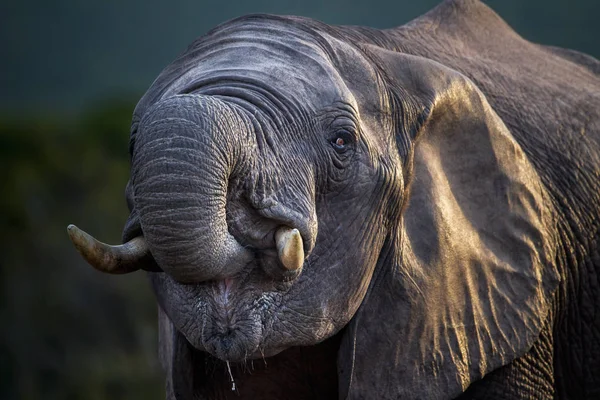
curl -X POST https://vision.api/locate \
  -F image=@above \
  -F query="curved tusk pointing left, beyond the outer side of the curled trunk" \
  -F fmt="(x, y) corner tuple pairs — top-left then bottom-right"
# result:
(67, 225), (160, 274)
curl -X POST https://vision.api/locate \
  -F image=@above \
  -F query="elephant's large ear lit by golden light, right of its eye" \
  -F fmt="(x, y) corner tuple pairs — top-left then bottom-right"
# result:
(338, 48), (559, 399)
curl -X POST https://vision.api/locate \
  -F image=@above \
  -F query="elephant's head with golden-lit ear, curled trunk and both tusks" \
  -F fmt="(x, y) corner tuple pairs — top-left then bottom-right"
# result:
(71, 16), (558, 399)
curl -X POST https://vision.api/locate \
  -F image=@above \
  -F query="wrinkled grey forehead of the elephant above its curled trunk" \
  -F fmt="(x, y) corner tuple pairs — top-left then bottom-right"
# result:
(140, 17), (354, 111)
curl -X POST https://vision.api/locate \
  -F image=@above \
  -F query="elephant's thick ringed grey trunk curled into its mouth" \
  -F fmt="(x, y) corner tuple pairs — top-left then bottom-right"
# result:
(132, 95), (252, 283)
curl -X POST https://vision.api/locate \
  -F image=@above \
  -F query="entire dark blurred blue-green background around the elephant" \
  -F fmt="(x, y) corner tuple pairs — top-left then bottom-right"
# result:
(0, 0), (600, 399)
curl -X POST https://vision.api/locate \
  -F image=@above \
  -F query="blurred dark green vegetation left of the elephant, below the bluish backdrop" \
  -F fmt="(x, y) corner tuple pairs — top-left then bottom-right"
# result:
(0, 99), (164, 400)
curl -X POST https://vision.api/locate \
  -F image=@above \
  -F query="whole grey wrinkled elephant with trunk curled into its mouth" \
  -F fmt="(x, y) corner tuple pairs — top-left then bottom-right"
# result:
(68, 0), (600, 400)
